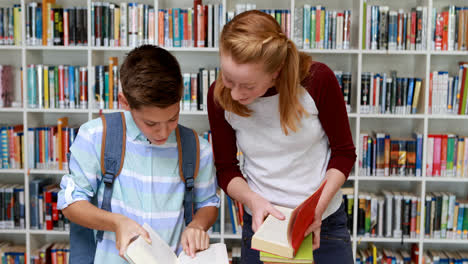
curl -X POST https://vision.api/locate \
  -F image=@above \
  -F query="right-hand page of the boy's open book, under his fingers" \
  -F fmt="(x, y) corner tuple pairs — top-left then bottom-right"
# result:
(179, 243), (229, 264)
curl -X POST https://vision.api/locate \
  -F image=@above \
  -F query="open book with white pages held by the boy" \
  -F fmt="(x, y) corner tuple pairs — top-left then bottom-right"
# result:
(125, 223), (229, 264)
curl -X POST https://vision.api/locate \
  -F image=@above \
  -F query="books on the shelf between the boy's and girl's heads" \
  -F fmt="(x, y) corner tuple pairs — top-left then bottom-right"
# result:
(180, 68), (219, 111)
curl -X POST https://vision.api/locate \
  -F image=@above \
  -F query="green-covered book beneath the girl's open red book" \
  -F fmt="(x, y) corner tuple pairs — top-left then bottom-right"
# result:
(260, 234), (314, 263)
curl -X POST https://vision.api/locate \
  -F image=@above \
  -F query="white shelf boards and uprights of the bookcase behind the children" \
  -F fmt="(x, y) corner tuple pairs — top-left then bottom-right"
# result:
(0, 0), (468, 263)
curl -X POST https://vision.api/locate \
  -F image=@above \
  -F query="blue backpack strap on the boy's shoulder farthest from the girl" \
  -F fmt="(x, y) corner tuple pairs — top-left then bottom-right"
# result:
(96, 112), (126, 241)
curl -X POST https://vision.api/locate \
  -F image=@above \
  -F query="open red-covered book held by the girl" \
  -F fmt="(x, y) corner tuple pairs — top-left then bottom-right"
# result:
(252, 180), (326, 259)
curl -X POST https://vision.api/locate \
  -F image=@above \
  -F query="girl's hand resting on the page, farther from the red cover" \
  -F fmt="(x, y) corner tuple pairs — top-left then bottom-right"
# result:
(247, 193), (285, 232)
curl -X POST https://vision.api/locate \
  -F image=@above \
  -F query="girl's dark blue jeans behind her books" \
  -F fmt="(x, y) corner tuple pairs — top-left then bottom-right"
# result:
(241, 203), (354, 264)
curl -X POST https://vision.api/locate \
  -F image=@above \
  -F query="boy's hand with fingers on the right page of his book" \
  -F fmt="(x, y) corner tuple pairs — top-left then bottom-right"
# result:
(181, 225), (210, 258)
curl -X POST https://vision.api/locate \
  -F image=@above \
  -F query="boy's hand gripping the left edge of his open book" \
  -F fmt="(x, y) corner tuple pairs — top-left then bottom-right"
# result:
(115, 214), (151, 259)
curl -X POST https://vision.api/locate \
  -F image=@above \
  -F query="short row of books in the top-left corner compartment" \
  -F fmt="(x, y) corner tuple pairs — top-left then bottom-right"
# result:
(0, 4), (22, 45)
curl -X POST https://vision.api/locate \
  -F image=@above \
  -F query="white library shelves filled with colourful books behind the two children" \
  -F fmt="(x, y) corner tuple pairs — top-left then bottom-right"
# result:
(0, 0), (468, 264)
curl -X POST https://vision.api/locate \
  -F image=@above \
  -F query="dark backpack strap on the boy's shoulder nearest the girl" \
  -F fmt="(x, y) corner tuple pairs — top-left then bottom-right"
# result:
(176, 125), (200, 226)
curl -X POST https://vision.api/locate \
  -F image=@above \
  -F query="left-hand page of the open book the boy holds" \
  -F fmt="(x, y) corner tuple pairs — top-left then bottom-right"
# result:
(125, 223), (179, 264)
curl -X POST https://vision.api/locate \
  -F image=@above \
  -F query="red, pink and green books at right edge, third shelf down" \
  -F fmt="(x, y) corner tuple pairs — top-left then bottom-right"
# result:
(426, 134), (468, 178)
